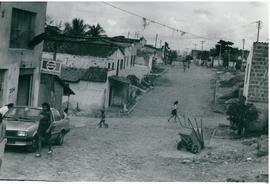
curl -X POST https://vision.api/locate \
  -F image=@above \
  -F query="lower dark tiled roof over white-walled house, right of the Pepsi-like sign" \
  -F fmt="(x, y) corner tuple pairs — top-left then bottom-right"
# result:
(61, 67), (108, 83)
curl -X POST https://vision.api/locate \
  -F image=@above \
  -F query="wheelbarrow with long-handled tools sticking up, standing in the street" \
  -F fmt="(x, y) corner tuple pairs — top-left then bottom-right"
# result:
(177, 119), (204, 153)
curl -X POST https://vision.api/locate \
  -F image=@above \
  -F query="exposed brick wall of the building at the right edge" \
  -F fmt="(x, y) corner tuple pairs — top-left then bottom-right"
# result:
(247, 42), (268, 103)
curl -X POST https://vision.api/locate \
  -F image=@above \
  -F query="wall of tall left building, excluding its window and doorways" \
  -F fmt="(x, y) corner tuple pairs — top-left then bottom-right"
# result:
(0, 2), (47, 106)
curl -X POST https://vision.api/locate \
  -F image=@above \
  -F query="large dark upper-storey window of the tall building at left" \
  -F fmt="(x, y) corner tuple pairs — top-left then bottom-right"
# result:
(10, 8), (36, 49)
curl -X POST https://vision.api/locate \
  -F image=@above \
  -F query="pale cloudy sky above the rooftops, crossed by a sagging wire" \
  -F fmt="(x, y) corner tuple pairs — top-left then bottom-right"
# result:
(47, 1), (269, 51)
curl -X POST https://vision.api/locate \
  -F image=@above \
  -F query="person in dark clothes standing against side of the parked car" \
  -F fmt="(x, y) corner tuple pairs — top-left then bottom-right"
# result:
(36, 102), (52, 157)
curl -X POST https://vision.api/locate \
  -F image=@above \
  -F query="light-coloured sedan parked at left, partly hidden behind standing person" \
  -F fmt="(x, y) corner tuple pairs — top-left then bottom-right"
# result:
(3, 106), (70, 152)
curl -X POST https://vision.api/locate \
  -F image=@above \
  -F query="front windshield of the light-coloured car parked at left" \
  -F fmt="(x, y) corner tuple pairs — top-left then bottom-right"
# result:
(5, 107), (41, 121)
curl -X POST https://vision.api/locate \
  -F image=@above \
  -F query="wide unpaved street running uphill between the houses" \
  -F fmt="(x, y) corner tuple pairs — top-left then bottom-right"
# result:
(0, 65), (268, 182)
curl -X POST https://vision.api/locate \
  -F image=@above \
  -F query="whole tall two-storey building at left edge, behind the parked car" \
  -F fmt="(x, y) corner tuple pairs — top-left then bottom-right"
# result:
(0, 2), (47, 106)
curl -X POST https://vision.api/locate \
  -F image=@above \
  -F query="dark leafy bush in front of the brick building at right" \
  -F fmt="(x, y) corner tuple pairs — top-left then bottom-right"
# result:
(226, 99), (259, 135)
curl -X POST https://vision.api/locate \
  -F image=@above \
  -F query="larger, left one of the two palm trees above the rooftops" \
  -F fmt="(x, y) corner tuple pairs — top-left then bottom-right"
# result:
(64, 18), (88, 36)
